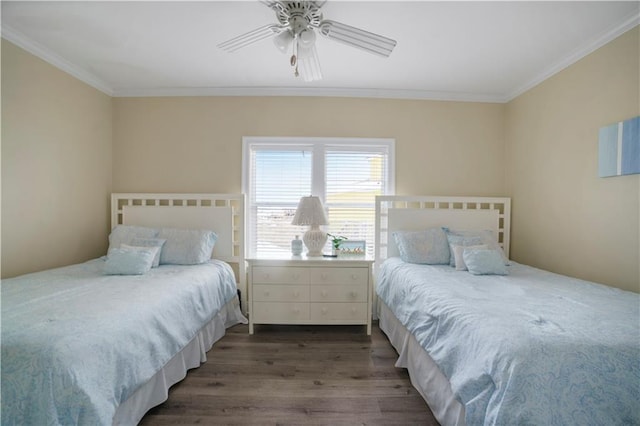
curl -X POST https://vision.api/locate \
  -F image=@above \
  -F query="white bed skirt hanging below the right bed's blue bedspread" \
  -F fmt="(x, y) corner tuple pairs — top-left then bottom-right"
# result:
(378, 299), (465, 426)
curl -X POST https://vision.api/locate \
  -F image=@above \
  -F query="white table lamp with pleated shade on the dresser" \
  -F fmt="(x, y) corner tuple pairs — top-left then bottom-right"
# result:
(291, 195), (329, 256)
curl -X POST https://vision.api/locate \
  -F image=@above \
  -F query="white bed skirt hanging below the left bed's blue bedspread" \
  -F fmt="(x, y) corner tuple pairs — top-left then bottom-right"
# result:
(113, 297), (248, 426)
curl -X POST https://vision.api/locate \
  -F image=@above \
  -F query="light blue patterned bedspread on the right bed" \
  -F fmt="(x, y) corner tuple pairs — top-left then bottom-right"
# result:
(377, 258), (640, 425)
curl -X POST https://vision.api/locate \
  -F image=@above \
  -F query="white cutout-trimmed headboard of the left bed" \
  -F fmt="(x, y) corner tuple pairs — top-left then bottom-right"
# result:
(111, 193), (247, 306)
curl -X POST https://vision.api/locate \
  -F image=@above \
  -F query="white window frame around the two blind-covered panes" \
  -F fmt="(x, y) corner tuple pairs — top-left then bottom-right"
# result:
(242, 136), (396, 257)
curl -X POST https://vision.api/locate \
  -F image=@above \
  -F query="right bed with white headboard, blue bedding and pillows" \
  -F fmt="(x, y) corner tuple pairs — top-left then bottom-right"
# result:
(375, 196), (640, 426)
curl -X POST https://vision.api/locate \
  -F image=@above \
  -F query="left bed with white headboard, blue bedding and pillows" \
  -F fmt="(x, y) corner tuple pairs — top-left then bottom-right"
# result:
(0, 193), (247, 426)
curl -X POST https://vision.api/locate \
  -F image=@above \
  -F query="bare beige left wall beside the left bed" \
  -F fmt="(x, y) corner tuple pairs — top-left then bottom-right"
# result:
(2, 39), (112, 278)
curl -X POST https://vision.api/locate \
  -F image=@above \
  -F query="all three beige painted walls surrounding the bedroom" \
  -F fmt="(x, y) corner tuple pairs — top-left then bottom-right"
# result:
(2, 28), (640, 291)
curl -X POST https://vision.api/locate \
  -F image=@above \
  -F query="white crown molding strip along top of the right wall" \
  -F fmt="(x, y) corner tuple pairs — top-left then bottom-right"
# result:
(503, 12), (640, 102)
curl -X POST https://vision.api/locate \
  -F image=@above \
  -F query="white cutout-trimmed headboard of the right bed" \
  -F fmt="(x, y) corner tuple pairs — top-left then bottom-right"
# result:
(375, 195), (511, 267)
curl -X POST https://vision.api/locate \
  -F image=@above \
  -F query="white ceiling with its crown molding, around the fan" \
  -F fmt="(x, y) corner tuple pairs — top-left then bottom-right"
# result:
(2, 0), (640, 102)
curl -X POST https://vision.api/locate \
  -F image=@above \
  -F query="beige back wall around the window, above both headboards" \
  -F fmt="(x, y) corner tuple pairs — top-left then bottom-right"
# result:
(113, 97), (504, 195)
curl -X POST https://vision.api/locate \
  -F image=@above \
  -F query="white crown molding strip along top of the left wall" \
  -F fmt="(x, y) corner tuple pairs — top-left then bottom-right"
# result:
(2, 24), (113, 96)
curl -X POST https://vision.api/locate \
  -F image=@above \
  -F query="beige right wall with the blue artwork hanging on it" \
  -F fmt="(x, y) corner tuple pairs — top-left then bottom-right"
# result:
(505, 27), (640, 292)
